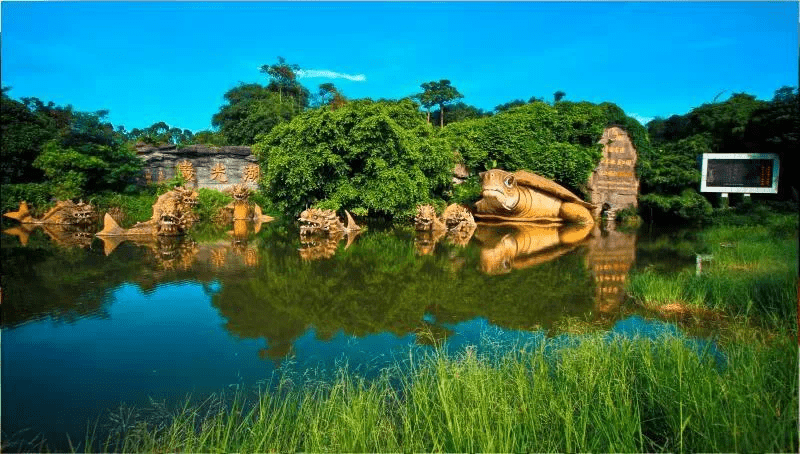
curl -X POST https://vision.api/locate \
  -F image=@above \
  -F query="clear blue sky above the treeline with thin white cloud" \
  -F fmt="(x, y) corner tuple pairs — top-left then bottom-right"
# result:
(1, 2), (799, 131)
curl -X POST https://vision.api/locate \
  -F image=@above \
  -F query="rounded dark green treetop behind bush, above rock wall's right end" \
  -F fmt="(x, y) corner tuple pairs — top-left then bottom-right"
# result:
(211, 83), (295, 145)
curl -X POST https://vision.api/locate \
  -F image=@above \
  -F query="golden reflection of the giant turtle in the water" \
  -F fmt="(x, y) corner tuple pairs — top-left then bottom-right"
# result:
(475, 222), (592, 274)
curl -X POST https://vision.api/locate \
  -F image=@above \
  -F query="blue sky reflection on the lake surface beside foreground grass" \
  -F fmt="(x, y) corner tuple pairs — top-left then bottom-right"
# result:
(2, 281), (723, 446)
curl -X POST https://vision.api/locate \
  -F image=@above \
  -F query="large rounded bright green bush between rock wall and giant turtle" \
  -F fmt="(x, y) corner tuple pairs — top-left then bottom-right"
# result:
(253, 100), (453, 216)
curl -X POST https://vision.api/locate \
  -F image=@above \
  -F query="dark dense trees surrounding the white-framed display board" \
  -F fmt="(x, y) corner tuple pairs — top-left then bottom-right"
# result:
(640, 87), (800, 219)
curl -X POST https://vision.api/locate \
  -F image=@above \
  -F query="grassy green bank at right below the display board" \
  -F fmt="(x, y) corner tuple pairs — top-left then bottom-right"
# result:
(627, 213), (798, 330)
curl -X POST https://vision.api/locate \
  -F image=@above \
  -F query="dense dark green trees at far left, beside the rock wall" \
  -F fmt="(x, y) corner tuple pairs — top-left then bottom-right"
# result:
(0, 91), (142, 204)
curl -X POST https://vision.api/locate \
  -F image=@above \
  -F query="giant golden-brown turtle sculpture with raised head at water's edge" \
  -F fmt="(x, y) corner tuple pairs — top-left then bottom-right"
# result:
(475, 169), (594, 224)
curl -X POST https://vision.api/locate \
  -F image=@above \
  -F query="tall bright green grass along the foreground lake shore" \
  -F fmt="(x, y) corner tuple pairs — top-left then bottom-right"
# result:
(83, 335), (798, 452)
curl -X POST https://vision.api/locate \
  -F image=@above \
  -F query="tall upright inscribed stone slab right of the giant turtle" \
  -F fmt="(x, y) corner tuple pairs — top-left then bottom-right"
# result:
(588, 126), (639, 220)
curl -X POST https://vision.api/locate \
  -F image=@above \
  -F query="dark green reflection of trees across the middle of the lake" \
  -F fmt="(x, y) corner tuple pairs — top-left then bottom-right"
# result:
(213, 232), (593, 357)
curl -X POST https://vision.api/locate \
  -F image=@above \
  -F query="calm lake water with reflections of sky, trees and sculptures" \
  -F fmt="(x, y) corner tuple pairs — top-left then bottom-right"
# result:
(1, 222), (703, 450)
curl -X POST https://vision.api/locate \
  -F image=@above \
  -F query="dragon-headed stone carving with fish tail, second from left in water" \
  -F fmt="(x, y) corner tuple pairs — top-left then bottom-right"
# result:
(97, 188), (197, 237)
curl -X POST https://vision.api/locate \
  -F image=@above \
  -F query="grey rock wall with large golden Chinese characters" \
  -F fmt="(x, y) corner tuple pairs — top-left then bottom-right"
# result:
(136, 144), (261, 191)
